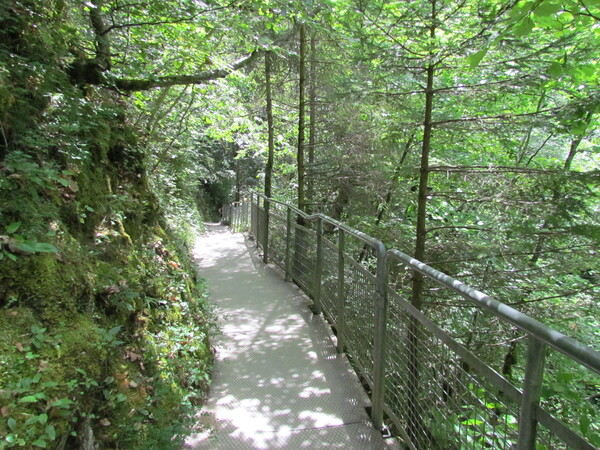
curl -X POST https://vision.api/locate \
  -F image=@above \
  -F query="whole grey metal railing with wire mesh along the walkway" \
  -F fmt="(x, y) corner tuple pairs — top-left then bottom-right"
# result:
(224, 194), (600, 449)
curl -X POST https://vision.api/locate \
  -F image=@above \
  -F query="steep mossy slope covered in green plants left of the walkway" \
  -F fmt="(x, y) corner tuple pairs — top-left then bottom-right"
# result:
(0, 1), (212, 448)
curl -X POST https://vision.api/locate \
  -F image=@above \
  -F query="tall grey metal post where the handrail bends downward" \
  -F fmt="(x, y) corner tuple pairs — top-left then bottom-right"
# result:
(371, 248), (387, 431)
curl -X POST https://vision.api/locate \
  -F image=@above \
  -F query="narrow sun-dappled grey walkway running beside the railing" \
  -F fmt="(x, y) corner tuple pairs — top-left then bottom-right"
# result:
(186, 224), (386, 450)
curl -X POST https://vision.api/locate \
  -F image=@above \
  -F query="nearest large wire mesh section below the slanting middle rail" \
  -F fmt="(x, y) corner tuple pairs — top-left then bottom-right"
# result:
(385, 292), (518, 449)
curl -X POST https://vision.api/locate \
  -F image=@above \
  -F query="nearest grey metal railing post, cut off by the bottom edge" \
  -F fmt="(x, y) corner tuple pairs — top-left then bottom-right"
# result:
(517, 336), (546, 450)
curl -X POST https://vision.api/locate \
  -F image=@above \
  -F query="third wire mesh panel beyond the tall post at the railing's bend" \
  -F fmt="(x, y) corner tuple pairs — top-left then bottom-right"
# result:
(292, 223), (317, 297)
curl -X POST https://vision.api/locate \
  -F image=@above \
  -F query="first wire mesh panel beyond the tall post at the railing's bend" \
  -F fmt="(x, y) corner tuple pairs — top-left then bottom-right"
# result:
(344, 256), (376, 384)
